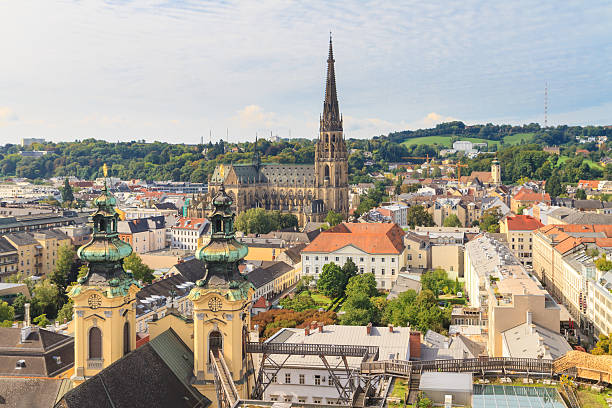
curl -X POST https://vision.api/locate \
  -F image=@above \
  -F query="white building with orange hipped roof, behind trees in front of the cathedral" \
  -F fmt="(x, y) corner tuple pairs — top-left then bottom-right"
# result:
(302, 223), (406, 290)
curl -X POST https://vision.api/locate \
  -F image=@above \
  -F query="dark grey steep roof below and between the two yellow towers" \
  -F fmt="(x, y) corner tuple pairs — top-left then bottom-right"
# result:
(57, 329), (211, 408)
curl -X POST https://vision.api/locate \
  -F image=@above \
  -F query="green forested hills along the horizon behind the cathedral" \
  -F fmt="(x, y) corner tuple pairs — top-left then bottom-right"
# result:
(0, 122), (612, 182)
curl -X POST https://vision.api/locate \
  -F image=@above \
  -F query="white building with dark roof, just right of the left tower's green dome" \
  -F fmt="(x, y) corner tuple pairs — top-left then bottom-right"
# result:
(117, 216), (167, 254)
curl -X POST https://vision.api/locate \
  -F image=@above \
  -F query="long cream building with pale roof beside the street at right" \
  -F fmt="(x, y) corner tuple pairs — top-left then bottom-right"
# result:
(465, 233), (571, 358)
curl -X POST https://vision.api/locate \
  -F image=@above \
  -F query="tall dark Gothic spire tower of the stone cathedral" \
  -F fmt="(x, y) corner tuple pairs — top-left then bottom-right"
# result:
(315, 36), (348, 215)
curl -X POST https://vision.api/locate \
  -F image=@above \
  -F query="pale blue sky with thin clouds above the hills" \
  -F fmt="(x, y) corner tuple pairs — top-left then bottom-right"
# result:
(0, 0), (612, 144)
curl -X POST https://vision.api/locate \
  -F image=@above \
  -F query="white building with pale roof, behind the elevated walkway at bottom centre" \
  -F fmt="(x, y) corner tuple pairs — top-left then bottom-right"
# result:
(263, 325), (410, 404)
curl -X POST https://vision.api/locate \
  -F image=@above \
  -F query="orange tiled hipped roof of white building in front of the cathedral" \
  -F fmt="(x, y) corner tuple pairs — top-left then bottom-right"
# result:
(302, 223), (404, 254)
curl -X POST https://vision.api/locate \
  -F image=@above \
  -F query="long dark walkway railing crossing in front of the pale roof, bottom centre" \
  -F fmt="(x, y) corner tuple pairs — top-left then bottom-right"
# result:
(246, 342), (378, 358)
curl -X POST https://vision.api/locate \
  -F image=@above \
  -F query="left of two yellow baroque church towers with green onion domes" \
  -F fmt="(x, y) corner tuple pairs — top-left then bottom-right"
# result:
(68, 165), (140, 385)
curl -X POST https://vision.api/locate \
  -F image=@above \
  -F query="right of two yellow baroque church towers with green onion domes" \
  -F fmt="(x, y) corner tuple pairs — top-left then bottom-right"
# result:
(189, 184), (254, 401)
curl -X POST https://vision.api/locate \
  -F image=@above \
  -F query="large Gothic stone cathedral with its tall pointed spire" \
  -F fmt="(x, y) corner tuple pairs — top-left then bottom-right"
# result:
(188, 38), (349, 225)
